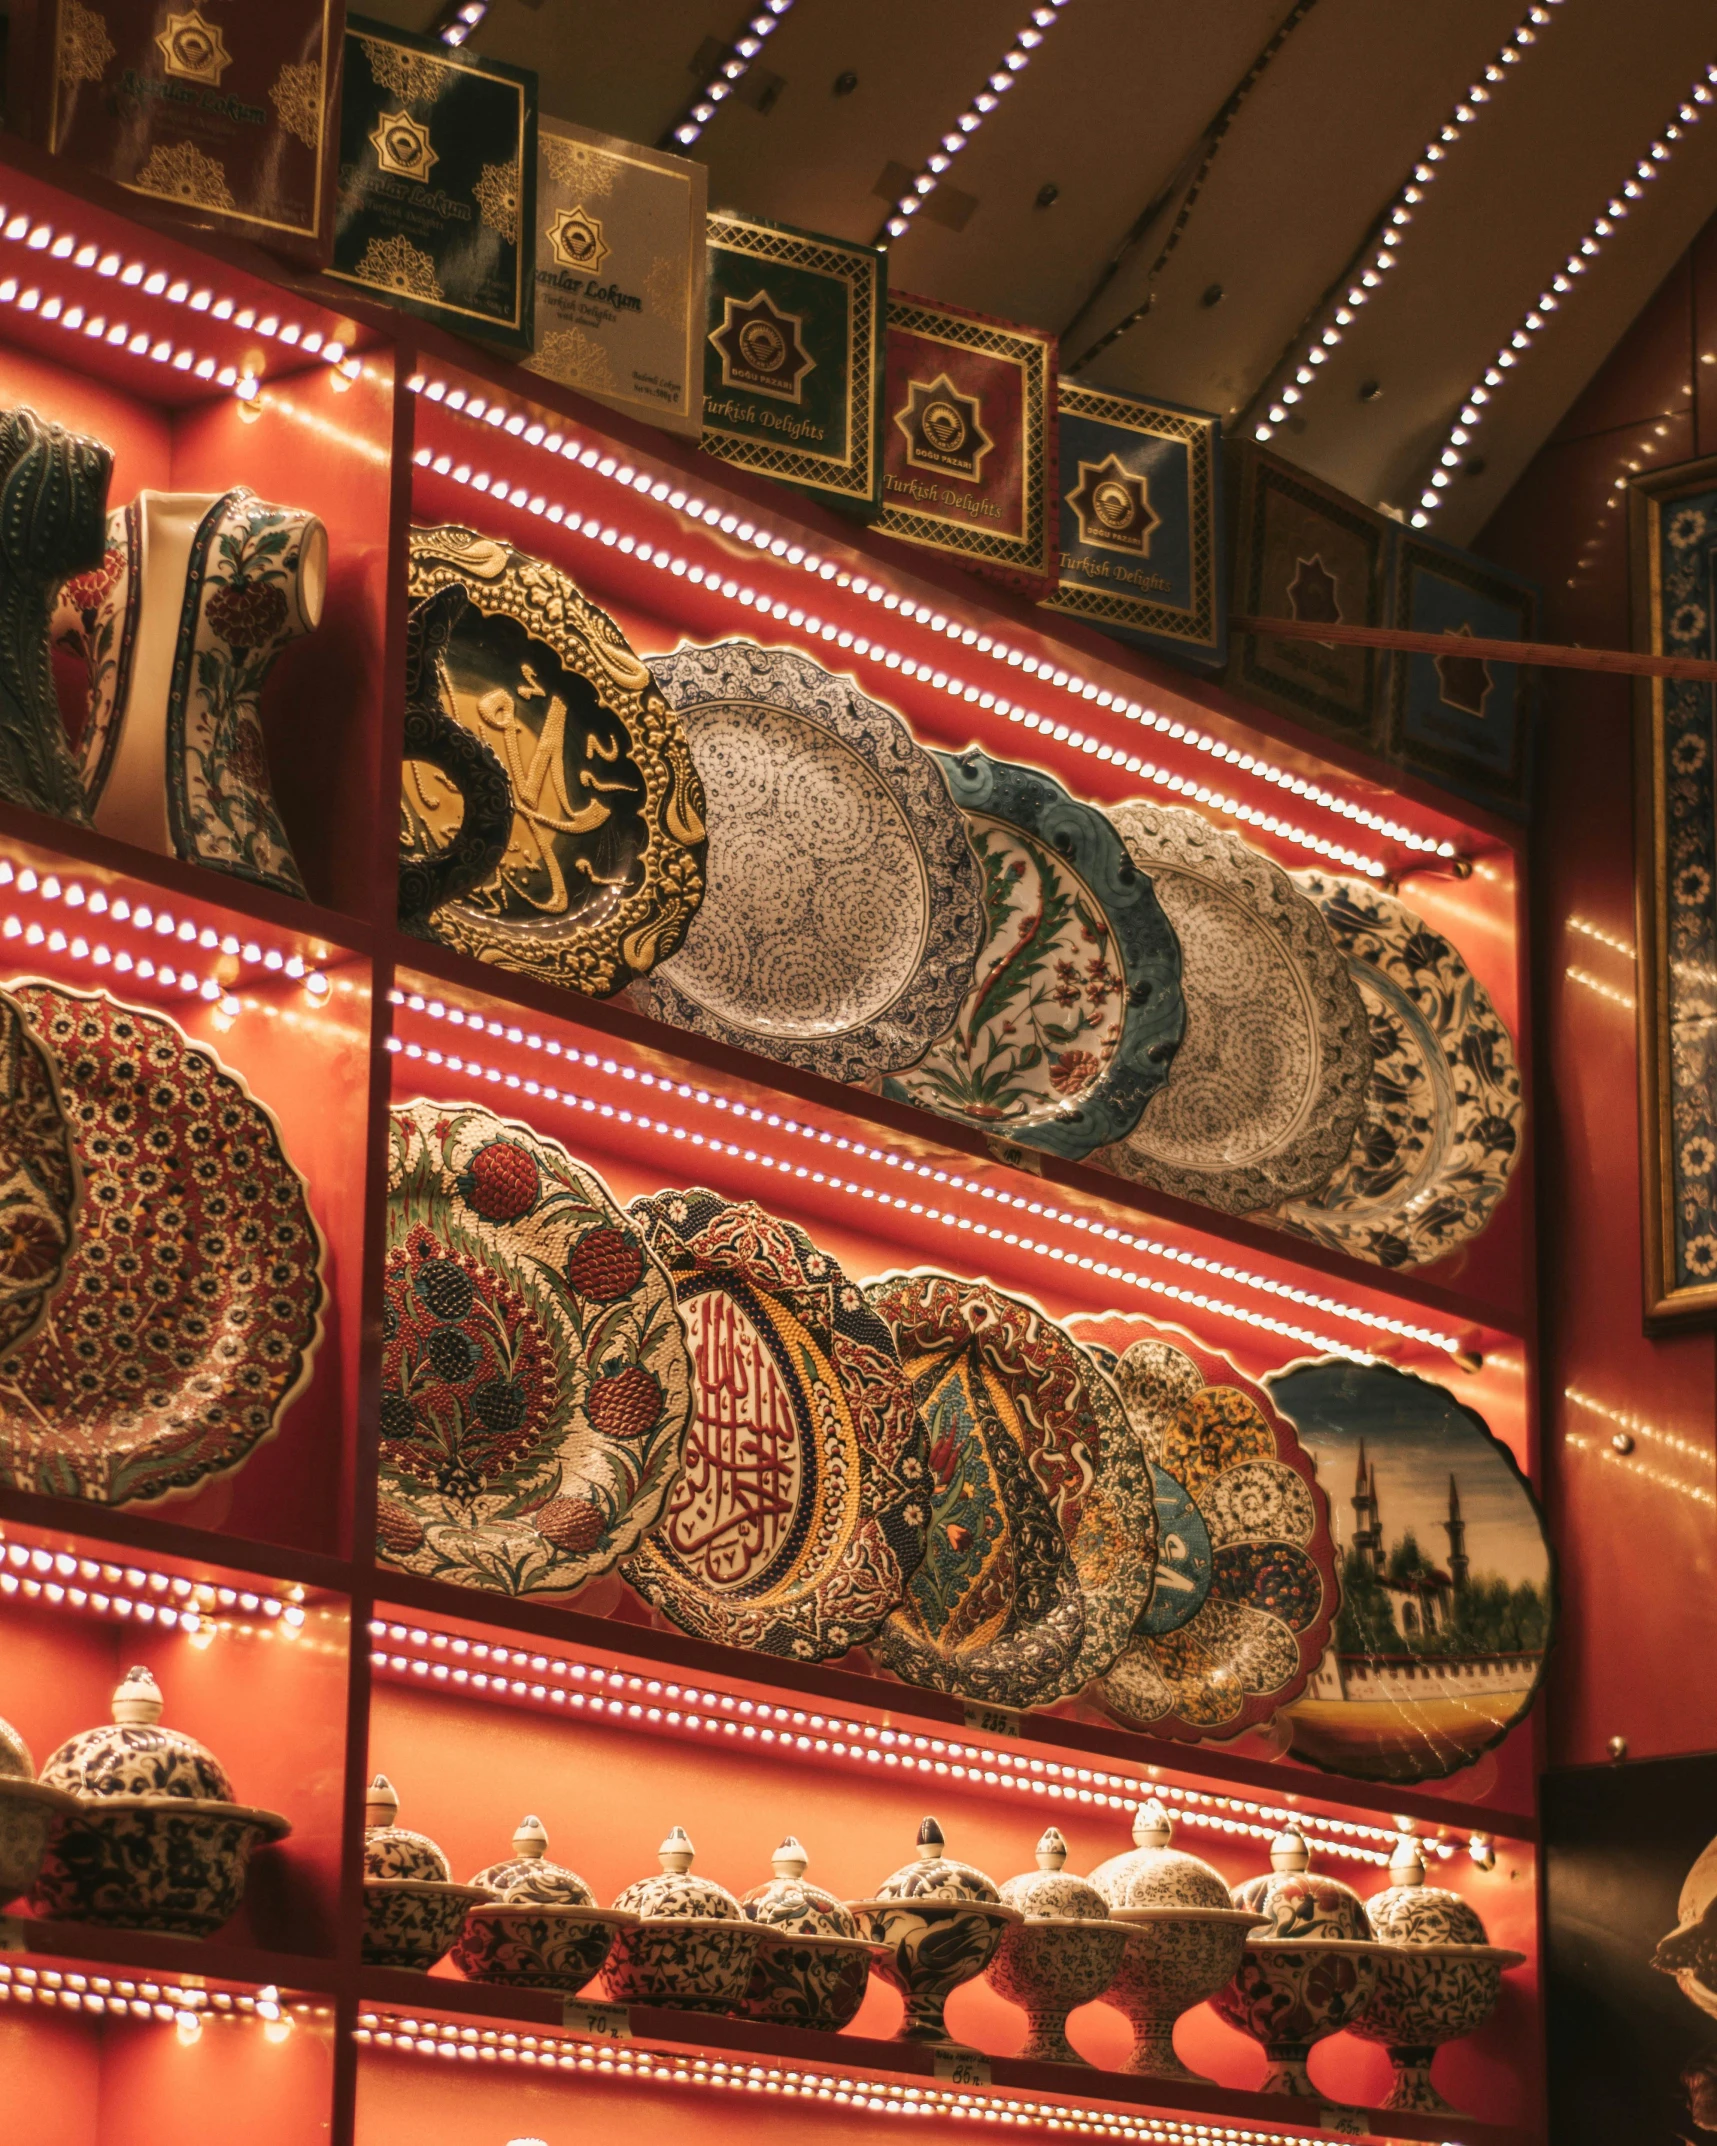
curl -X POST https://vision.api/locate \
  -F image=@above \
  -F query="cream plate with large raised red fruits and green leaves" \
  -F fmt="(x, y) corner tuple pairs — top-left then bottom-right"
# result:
(376, 1101), (691, 1594)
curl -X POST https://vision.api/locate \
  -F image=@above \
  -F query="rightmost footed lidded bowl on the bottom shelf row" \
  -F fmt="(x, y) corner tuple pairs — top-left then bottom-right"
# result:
(1354, 1833), (1526, 2116)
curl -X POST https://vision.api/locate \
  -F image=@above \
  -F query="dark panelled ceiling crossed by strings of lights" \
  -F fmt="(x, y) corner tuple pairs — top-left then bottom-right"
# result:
(365, 0), (1717, 543)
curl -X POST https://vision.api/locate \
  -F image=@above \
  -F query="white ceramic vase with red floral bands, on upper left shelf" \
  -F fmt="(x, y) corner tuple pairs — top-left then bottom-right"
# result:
(54, 485), (328, 895)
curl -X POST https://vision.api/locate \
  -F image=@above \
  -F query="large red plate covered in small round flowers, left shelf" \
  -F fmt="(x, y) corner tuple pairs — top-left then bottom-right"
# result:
(0, 983), (322, 1504)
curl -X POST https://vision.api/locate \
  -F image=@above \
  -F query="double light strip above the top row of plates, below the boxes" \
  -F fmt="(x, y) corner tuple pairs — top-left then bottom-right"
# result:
(406, 373), (1459, 878)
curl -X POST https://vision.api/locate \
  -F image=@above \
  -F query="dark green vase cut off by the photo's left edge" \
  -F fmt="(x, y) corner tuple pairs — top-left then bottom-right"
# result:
(0, 410), (114, 826)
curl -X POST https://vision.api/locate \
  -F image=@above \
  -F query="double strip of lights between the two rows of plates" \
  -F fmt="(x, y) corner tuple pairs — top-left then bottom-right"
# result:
(386, 987), (1462, 1356)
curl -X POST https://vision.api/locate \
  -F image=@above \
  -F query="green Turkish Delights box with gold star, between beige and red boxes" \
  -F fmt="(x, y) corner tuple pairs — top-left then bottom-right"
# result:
(704, 215), (886, 515)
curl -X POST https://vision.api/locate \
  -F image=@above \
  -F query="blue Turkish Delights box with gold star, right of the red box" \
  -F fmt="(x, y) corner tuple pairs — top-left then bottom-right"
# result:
(1045, 380), (1228, 665)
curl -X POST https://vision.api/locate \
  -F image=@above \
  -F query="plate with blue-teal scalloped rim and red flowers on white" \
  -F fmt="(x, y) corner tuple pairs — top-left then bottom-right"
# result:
(886, 749), (1185, 1161)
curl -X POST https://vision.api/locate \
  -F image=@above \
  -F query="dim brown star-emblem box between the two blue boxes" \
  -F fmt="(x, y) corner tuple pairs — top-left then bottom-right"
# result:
(1223, 444), (1395, 753)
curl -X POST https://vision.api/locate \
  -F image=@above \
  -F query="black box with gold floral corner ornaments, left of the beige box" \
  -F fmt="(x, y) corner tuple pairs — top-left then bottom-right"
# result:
(331, 15), (537, 352)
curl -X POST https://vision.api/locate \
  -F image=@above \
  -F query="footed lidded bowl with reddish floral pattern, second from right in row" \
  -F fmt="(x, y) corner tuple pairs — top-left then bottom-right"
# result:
(1210, 1831), (1380, 2097)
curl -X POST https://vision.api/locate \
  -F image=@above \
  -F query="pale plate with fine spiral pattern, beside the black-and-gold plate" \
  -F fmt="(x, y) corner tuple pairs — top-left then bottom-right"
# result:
(633, 642), (983, 1079)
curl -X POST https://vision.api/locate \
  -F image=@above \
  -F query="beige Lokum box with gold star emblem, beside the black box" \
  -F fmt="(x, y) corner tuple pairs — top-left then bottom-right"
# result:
(524, 118), (708, 440)
